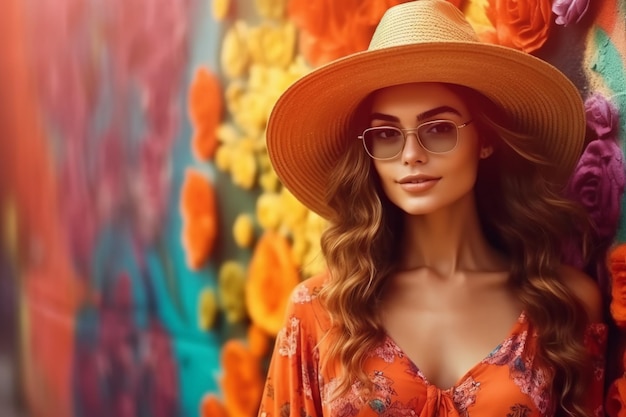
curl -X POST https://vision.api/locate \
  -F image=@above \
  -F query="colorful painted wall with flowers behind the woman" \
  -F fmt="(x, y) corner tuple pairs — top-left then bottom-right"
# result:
(0, 0), (626, 417)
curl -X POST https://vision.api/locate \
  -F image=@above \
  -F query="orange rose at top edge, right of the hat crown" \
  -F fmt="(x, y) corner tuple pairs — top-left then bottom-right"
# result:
(483, 0), (552, 52)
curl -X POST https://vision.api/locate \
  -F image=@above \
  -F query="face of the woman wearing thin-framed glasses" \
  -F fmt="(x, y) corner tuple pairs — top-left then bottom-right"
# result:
(369, 83), (491, 215)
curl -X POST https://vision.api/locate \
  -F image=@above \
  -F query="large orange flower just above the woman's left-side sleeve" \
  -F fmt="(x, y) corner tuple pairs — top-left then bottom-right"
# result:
(246, 232), (300, 336)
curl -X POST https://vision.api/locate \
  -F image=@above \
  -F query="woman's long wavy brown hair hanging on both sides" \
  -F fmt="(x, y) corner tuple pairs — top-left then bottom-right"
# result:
(321, 85), (589, 417)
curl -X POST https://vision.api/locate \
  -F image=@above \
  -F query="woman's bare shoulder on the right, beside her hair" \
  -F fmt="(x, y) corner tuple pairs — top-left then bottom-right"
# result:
(559, 265), (603, 323)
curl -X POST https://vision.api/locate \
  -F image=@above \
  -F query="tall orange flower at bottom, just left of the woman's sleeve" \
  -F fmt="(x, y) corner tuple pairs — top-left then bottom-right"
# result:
(221, 339), (263, 417)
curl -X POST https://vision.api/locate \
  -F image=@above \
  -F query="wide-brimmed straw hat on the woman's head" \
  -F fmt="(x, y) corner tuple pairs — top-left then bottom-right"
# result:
(266, 0), (585, 217)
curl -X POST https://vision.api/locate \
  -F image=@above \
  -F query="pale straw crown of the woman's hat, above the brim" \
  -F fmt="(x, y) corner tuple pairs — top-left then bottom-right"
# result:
(368, 0), (479, 51)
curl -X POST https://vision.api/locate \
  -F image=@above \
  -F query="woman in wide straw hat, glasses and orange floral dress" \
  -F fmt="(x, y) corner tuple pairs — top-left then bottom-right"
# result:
(259, 0), (606, 417)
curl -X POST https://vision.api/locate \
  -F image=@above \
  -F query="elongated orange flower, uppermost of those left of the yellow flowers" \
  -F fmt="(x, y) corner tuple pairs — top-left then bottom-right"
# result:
(189, 67), (224, 160)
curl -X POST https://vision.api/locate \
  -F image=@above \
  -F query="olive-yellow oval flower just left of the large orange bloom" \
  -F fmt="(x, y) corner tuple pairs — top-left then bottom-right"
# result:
(218, 261), (246, 323)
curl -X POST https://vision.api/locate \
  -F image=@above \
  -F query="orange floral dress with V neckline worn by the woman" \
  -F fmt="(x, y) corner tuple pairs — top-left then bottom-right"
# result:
(258, 276), (607, 417)
